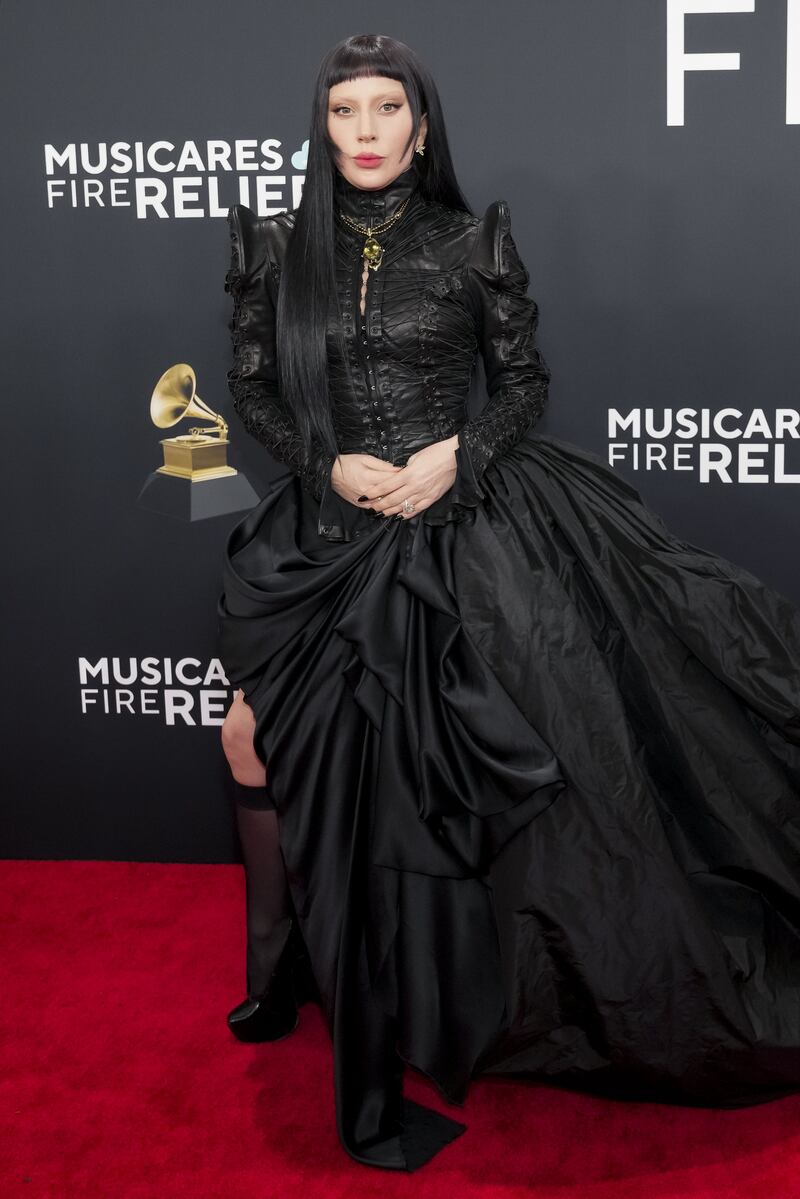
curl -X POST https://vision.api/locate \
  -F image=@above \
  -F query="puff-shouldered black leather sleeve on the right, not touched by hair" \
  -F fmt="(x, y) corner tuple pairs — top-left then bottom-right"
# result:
(458, 200), (551, 480)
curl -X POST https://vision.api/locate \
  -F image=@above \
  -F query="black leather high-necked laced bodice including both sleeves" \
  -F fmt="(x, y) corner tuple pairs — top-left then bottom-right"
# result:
(225, 162), (549, 540)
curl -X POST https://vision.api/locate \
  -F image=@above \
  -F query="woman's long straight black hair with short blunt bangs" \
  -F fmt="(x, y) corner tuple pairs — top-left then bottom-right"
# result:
(276, 34), (473, 453)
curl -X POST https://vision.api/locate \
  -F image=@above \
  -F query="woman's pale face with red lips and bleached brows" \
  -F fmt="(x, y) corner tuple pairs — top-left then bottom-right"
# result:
(327, 76), (428, 189)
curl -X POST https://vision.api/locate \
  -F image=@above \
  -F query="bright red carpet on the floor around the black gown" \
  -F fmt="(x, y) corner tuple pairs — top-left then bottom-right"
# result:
(0, 861), (800, 1199)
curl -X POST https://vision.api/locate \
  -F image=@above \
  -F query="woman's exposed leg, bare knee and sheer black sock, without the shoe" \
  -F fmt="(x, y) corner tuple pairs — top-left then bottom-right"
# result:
(222, 691), (293, 999)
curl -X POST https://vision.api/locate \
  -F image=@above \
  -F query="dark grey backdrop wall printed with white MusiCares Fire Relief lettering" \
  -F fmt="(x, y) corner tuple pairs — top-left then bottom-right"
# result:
(0, 0), (800, 861)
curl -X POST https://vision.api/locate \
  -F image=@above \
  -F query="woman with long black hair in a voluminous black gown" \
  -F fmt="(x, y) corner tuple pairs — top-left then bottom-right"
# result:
(219, 35), (800, 1170)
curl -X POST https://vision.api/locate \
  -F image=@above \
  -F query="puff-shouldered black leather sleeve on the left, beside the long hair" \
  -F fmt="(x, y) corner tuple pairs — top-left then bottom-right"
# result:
(225, 204), (336, 500)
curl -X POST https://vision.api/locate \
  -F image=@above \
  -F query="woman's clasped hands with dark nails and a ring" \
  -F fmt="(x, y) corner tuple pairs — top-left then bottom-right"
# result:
(331, 434), (458, 519)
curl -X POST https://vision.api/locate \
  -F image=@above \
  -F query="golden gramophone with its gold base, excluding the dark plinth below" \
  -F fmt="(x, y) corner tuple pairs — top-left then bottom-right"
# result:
(150, 362), (237, 483)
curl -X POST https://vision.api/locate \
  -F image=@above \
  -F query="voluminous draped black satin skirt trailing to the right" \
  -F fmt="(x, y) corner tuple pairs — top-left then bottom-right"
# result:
(219, 432), (800, 1170)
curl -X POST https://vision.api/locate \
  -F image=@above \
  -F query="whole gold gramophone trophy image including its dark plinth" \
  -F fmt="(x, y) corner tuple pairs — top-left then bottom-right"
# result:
(138, 362), (258, 520)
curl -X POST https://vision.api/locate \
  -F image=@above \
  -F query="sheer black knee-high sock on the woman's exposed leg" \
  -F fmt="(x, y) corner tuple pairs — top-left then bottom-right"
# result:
(235, 783), (293, 999)
